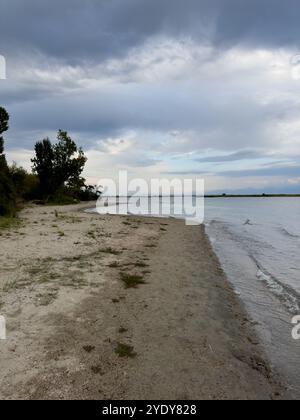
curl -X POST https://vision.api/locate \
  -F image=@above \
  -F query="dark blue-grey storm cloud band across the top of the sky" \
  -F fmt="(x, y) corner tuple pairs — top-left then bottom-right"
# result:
(0, 0), (300, 62)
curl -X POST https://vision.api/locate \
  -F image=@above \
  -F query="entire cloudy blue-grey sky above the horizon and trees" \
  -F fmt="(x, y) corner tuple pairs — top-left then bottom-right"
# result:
(0, 0), (300, 193)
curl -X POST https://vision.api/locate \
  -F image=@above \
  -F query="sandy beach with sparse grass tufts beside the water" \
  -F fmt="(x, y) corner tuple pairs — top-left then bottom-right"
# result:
(0, 206), (283, 399)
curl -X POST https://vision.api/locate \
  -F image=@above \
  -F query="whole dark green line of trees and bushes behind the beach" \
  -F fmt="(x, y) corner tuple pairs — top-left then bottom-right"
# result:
(0, 107), (98, 216)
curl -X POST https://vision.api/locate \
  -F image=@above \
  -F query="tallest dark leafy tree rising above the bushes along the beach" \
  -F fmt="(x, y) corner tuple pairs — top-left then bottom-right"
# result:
(32, 130), (86, 199)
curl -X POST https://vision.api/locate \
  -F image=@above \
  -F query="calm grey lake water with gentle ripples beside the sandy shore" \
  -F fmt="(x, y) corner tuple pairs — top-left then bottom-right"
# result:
(89, 198), (300, 397)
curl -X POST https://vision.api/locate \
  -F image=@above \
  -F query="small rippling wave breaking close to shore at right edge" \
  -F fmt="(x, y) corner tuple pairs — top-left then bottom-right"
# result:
(251, 256), (300, 315)
